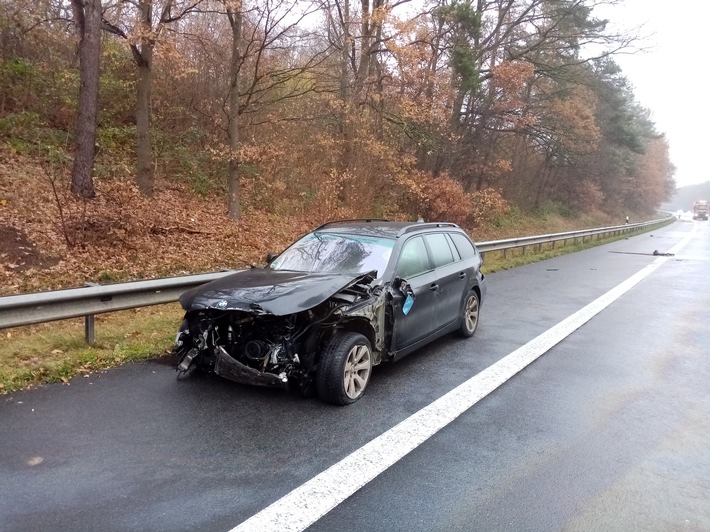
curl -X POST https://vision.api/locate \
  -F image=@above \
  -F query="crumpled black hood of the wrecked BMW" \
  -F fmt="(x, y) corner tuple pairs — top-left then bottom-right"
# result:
(180, 268), (374, 316)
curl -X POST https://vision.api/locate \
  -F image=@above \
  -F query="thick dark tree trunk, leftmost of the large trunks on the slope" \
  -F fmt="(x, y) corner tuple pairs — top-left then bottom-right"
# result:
(71, 0), (101, 198)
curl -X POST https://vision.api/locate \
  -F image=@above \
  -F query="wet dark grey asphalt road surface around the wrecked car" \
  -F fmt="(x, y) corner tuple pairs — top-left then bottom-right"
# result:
(0, 223), (710, 531)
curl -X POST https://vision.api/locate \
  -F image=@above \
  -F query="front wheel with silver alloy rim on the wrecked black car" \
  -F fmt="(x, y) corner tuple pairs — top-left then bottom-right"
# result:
(316, 332), (372, 405)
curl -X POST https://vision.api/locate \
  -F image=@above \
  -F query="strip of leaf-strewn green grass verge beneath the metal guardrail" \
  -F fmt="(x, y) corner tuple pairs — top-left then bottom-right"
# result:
(0, 213), (672, 393)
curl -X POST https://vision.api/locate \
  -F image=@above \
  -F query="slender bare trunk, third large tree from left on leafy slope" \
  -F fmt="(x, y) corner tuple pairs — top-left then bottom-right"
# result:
(227, 8), (242, 220)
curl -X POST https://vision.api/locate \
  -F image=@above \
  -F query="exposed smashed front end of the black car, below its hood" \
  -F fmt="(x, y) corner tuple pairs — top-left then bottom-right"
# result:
(175, 274), (384, 390)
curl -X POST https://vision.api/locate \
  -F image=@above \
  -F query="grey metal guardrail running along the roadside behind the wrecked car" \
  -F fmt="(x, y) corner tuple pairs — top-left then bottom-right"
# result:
(0, 218), (672, 345)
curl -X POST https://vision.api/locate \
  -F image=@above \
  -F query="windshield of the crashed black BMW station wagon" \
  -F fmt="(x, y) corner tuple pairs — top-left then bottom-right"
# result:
(269, 233), (394, 277)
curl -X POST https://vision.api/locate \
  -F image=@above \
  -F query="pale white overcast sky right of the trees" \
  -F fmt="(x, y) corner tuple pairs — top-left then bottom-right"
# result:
(594, 0), (710, 187)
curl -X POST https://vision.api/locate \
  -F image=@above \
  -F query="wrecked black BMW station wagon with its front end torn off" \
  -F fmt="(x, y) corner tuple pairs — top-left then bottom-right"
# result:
(175, 220), (486, 405)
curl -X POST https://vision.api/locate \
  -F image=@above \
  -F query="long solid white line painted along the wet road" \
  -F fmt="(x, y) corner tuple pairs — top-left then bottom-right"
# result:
(230, 225), (696, 532)
